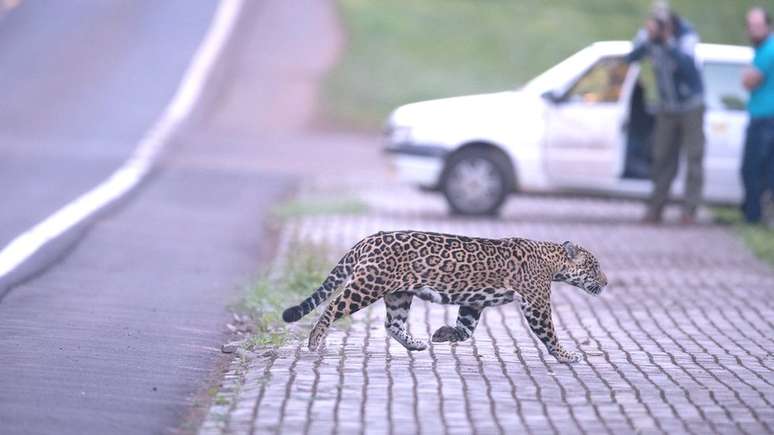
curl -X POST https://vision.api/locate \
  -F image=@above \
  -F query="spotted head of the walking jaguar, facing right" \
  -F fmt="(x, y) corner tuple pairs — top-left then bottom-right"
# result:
(554, 242), (607, 295)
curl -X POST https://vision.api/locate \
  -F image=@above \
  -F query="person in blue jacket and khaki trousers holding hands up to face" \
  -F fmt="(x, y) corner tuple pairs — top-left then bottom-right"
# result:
(626, 1), (704, 223)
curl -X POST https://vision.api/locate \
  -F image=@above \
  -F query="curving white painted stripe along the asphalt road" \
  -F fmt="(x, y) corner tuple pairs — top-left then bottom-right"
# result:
(0, 0), (243, 278)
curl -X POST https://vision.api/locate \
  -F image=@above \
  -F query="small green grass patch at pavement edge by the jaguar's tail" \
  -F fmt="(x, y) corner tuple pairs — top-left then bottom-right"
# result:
(244, 243), (333, 346)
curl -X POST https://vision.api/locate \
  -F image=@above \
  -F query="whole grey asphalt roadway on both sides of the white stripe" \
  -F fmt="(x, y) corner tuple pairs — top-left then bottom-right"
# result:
(0, 0), (350, 434)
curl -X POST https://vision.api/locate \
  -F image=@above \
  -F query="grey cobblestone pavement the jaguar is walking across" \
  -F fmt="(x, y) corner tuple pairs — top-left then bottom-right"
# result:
(201, 188), (774, 434)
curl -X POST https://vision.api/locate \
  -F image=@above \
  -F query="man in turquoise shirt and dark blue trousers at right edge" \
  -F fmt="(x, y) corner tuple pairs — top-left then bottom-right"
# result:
(742, 8), (774, 223)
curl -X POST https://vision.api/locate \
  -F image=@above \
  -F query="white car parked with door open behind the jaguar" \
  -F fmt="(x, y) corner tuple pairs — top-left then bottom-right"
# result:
(385, 41), (753, 215)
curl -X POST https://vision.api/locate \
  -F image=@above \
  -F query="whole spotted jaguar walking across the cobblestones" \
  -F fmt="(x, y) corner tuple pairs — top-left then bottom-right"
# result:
(282, 231), (607, 362)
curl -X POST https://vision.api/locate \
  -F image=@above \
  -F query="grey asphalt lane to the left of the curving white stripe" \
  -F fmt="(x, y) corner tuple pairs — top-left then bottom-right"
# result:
(0, 1), (215, 255)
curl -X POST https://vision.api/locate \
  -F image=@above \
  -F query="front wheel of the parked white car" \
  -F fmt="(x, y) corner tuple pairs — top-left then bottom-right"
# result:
(441, 148), (512, 216)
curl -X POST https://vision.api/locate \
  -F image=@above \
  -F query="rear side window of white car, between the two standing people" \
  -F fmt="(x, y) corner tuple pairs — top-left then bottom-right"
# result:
(704, 61), (747, 111)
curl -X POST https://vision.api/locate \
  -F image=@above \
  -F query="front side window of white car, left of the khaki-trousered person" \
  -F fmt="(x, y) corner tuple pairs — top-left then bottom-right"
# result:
(565, 58), (629, 103)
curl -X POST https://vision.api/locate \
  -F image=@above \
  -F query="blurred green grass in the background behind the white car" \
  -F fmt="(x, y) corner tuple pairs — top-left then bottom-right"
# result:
(323, 0), (774, 129)
